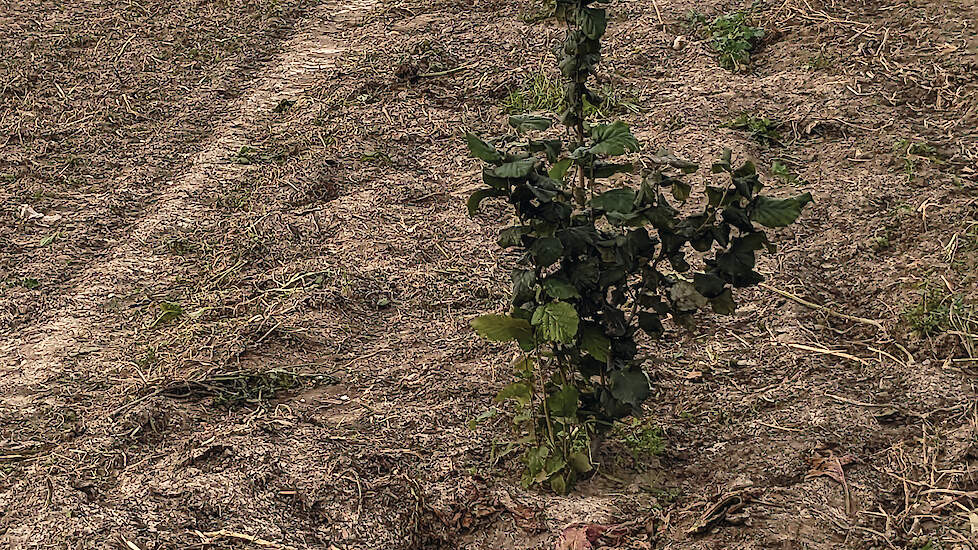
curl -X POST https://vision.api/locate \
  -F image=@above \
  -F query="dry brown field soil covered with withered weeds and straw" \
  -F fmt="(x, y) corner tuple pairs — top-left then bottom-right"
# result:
(0, 0), (978, 550)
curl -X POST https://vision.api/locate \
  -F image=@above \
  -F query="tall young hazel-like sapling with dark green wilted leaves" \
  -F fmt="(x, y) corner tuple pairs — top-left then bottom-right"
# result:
(466, 0), (812, 493)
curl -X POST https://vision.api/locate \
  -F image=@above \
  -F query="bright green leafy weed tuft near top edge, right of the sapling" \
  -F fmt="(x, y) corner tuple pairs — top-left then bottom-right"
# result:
(686, 10), (764, 72)
